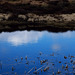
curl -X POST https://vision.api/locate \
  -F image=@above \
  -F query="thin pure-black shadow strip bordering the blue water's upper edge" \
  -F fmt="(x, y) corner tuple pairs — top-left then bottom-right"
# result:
(0, 26), (74, 33)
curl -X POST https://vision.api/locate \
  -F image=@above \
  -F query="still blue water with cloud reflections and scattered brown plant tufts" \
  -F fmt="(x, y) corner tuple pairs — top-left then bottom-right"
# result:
(0, 31), (75, 75)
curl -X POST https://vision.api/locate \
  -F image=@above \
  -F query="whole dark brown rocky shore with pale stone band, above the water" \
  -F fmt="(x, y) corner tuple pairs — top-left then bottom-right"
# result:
(0, 1), (75, 32)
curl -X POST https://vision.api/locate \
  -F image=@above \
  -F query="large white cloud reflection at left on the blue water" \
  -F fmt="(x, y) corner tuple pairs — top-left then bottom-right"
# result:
(0, 31), (43, 46)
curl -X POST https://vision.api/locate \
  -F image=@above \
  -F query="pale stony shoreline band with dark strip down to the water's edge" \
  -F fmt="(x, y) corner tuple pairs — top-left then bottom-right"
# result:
(0, 13), (75, 32)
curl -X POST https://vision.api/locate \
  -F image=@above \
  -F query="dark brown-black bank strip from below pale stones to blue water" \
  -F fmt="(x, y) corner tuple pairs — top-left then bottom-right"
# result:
(0, 22), (75, 32)
